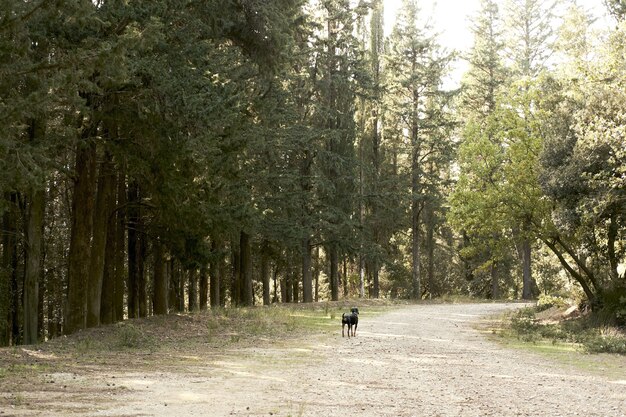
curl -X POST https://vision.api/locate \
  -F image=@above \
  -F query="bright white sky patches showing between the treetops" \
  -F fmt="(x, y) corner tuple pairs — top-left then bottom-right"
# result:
(383, 0), (606, 84)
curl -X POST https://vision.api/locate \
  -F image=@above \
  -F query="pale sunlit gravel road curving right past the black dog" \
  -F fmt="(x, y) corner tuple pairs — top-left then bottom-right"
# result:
(89, 304), (626, 417)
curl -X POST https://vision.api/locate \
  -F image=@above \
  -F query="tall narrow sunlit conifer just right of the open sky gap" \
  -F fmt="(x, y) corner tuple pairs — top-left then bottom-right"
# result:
(450, 0), (510, 298)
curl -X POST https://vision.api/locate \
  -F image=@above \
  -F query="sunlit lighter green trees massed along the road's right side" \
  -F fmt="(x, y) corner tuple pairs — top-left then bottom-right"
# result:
(450, 0), (626, 310)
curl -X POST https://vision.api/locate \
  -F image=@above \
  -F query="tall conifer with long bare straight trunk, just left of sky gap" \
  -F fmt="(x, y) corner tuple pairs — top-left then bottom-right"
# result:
(387, 0), (451, 299)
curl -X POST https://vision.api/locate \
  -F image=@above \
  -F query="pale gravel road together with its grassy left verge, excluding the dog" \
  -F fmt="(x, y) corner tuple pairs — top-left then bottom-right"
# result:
(0, 303), (626, 417)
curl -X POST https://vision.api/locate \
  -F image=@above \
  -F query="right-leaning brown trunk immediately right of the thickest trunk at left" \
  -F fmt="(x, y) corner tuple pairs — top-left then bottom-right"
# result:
(87, 152), (115, 327)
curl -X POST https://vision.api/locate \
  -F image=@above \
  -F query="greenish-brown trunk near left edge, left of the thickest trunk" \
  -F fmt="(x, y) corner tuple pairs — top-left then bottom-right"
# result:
(23, 189), (45, 345)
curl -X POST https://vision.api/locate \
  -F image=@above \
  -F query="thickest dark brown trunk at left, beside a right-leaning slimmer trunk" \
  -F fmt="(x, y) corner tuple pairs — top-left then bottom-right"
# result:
(63, 141), (96, 334)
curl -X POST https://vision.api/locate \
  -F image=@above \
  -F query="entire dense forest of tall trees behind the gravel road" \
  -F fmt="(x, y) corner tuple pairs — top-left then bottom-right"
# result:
(0, 0), (626, 346)
